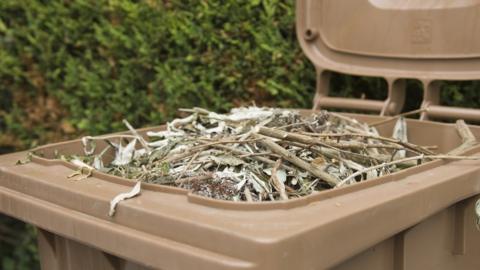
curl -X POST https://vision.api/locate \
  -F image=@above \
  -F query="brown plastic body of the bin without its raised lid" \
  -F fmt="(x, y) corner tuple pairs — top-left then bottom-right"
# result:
(0, 115), (480, 270)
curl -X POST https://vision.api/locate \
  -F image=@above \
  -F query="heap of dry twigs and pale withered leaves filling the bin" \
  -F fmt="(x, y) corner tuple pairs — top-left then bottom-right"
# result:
(64, 107), (476, 202)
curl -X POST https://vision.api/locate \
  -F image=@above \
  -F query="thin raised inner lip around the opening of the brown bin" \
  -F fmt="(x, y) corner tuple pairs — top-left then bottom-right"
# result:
(27, 110), (480, 211)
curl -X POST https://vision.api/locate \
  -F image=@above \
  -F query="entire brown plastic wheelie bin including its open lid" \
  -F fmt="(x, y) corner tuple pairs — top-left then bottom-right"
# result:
(0, 0), (480, 270)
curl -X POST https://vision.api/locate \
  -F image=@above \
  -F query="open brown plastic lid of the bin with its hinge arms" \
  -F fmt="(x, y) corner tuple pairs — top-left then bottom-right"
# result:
(296, 0), (480, 121)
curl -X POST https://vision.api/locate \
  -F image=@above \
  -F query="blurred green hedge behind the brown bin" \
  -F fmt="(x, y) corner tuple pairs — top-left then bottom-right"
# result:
(0, 0), (480, 270)
